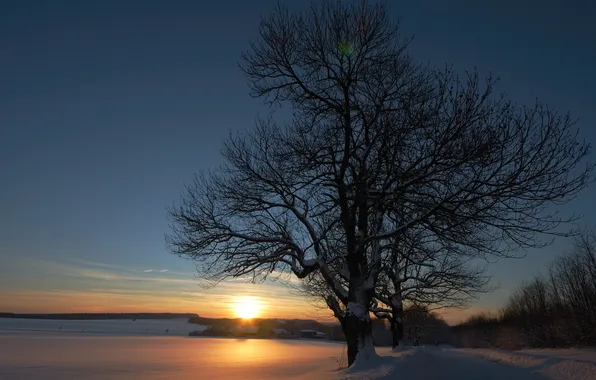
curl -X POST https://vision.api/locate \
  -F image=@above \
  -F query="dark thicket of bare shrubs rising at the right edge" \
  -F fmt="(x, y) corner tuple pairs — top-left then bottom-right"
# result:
(453, 230), (596, 349)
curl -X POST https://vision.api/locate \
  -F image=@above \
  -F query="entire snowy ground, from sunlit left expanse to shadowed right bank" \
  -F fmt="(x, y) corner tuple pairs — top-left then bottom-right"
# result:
(0, 319), (596, 380)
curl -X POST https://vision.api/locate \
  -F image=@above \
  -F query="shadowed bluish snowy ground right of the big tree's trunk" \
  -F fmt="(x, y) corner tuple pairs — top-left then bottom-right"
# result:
(338, 347), (596, 380)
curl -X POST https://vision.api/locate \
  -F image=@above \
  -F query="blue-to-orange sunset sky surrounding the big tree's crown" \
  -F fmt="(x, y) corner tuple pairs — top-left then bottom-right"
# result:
(0, 0), (596, 322)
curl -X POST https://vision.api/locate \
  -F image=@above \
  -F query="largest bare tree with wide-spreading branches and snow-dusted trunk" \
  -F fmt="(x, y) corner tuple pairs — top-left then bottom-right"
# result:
(167, 1), (591, 365)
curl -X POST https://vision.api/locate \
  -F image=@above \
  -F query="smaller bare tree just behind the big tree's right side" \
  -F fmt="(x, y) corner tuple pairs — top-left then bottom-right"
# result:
(371, 226), (491, 348)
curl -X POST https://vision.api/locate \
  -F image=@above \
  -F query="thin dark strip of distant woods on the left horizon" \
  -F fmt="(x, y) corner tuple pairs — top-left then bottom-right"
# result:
(0, 313), (199, 320)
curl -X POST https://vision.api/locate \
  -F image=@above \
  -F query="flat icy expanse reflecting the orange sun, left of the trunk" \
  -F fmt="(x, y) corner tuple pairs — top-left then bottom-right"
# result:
(0, 319), (344, 380)
